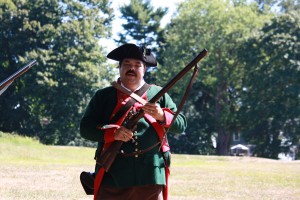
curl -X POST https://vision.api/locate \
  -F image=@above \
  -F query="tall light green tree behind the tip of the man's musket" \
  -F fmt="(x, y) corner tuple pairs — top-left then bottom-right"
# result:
(157, 0), (270, 155)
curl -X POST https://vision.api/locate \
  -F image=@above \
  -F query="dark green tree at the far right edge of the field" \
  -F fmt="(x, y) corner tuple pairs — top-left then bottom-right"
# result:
(240, 12), (300, 158)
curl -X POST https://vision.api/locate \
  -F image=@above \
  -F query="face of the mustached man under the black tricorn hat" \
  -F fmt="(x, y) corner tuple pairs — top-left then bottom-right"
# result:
(119, 58), (146, 90)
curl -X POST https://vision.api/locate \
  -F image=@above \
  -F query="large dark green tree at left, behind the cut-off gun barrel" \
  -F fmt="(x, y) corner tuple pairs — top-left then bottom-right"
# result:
(0, 0), (112, 144)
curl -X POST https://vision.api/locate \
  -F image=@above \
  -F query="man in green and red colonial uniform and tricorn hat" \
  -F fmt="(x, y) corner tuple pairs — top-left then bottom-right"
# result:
(80, 44), (186, 200)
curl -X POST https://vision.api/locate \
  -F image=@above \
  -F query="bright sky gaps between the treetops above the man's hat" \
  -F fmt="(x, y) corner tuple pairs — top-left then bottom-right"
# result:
(100, 0), (183, 52)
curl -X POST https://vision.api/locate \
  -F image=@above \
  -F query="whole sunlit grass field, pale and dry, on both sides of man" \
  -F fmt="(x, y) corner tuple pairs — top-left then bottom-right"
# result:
(0, 132), (300, 200)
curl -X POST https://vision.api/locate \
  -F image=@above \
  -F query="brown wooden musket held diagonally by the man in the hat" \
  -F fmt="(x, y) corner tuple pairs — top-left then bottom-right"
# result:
(97, 49), (208, 172)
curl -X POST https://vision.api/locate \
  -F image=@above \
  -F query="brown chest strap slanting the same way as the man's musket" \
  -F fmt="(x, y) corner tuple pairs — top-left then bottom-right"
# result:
(110, 83), (150, 124)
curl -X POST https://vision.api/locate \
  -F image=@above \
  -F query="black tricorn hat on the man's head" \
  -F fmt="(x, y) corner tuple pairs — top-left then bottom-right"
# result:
(107, 43), (157, 67)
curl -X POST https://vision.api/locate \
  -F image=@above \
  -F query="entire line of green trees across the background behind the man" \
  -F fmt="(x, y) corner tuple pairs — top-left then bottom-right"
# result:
(0, 0), (300, 158)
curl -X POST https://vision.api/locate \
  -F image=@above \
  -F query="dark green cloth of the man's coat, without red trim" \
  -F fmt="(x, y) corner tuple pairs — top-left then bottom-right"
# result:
(80, 85), (187, 187)
